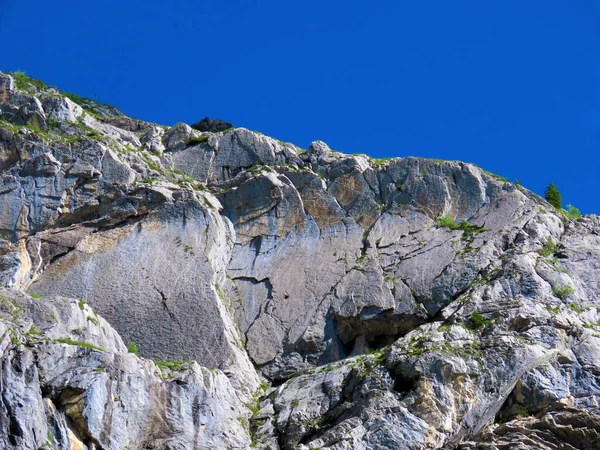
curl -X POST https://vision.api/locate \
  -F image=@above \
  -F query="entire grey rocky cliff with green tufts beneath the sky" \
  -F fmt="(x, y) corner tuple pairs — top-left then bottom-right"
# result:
(0, 74), (600, 450)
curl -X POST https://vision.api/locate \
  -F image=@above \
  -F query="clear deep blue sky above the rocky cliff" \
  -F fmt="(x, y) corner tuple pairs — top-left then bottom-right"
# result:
(0, 0), (600, 213)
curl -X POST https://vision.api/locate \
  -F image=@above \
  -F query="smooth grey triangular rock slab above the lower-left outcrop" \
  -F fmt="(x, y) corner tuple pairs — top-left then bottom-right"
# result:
(31, 198), (257, 398)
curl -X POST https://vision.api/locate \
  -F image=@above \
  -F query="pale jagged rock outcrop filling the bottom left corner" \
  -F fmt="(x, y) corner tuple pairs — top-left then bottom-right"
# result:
(0, 289), (249, 449)
